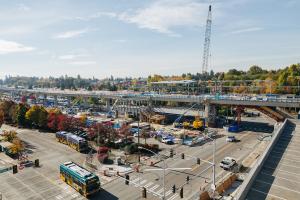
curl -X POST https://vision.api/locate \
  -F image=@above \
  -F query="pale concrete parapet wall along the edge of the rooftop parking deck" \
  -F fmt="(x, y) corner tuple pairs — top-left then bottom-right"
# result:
(234, 119), (288, 200)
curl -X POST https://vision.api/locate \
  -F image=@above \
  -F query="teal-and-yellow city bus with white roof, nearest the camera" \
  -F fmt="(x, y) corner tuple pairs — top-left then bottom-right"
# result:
(59, 162), (100, 197)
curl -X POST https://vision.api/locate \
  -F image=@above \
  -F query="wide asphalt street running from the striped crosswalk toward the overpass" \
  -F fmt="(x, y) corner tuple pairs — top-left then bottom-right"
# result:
(103, 132), (260, 200)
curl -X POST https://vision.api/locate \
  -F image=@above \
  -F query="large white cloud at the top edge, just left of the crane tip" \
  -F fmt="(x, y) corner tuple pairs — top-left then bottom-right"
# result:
(118, 0), (208, 36)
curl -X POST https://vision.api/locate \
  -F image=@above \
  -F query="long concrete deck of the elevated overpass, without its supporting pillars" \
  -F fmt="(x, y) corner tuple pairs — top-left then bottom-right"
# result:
(0, 87), (300, 108)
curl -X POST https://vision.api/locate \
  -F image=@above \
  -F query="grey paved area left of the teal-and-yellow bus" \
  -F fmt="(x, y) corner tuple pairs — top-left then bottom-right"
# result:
(0, 126), (85, 200)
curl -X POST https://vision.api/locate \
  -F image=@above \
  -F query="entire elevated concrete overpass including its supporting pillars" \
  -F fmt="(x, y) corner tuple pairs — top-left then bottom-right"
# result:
(0, 87), (300, 124)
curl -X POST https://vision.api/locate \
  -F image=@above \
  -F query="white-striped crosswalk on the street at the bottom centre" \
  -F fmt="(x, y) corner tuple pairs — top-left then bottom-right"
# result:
(130, 175), (180, 200)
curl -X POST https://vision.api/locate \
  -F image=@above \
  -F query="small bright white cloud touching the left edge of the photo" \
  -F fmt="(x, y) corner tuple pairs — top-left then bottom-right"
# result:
(0, 40), (35, 54)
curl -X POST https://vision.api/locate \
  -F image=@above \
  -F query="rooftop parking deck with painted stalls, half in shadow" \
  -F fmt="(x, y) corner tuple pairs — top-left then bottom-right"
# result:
(247, 122), (300, 200)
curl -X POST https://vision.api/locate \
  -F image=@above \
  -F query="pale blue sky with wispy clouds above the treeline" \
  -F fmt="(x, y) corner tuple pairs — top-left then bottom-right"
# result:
(0, 0), (300, 78)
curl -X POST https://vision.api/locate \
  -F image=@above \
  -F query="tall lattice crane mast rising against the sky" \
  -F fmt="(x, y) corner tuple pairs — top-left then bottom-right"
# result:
(202, 5), (212, 74)
